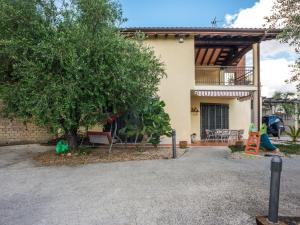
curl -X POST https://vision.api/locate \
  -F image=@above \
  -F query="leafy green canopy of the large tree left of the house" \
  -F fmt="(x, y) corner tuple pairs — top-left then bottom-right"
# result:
(0, 0), (165, 149)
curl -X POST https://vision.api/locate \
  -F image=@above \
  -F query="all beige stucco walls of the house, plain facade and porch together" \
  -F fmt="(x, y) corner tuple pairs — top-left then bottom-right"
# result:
(145, 37), (257, 143)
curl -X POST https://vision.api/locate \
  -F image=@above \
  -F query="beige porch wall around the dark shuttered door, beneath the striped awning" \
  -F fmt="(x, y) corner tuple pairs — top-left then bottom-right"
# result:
(191, 96), (251, 139)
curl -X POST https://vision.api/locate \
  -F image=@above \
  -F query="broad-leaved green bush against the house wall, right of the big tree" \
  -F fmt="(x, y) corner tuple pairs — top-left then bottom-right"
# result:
(120, 98), (172, 146)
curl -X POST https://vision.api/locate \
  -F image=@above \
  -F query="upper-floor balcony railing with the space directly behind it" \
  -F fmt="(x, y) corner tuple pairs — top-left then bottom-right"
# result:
(195, 66), (254, 86)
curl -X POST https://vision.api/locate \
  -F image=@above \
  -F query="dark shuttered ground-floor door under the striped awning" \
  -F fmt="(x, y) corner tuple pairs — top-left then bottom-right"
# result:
(200, 103), (229, 139)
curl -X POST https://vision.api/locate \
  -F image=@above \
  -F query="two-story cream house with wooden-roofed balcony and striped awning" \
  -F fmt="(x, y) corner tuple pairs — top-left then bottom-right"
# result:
(122, 27), (278, 143)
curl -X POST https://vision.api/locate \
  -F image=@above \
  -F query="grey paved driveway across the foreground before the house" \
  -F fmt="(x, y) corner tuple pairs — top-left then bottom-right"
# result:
(0, 146), (300, 225)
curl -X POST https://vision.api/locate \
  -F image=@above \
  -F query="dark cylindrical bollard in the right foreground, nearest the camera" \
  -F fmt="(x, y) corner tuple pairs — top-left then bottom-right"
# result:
(268, 156), (282, 223)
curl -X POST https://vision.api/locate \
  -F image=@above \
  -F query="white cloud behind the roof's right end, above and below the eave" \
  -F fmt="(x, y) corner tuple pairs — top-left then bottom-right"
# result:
(225, 0), (296, 97)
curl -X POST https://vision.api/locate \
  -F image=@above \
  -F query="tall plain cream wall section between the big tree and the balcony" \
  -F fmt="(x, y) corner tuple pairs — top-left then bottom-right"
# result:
(145, 38), (195, 143)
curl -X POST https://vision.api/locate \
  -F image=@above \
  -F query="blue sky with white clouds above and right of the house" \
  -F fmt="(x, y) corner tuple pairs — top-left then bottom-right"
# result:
(119, 0), (296, 97)
